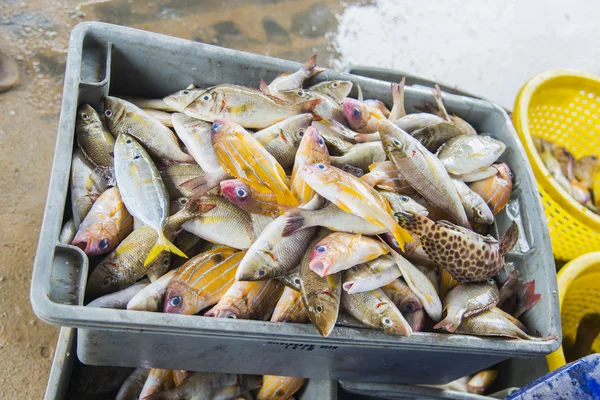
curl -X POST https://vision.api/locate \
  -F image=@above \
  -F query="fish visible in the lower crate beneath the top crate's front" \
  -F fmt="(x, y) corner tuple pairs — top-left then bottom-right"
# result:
(110, 368), (307, 400)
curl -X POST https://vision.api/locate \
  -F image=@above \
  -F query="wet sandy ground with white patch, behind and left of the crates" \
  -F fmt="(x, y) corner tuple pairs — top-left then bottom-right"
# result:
(0, 0), (600, 399)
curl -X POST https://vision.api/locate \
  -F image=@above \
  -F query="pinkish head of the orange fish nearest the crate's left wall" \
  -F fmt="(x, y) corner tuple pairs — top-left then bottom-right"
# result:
(71, 219), (119, 256)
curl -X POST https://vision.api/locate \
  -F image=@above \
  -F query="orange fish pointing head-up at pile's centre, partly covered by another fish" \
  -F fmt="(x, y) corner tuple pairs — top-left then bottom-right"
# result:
(291, 126), (329, 204)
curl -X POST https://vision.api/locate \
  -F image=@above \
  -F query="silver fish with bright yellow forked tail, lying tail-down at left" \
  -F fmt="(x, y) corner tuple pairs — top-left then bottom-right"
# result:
(115, 133), (187, 265)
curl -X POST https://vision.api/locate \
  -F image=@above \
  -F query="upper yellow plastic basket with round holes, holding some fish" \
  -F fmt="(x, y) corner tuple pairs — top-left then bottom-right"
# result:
(513, 70), (600, 261)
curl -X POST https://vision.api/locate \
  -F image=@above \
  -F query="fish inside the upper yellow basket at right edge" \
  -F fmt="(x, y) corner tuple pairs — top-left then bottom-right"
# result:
(533, 137), (600, 215)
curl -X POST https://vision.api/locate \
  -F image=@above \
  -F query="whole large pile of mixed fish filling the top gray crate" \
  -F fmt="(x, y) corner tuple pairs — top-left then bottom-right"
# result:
(61, 57), (539, 352)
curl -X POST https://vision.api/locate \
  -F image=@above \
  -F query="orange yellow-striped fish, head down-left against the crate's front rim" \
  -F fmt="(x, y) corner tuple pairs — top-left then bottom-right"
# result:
(163, 247), (245, 314)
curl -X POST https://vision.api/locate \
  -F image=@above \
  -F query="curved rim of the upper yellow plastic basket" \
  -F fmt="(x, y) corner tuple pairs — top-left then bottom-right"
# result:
(513, 69), (600, 233)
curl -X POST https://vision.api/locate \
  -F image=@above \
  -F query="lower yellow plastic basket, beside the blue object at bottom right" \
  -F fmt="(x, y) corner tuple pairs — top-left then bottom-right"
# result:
(546, 252), (600, 371)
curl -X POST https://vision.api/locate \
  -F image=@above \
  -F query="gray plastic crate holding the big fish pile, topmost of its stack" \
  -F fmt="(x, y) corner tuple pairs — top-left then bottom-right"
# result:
(31, 22), (561, 384)
